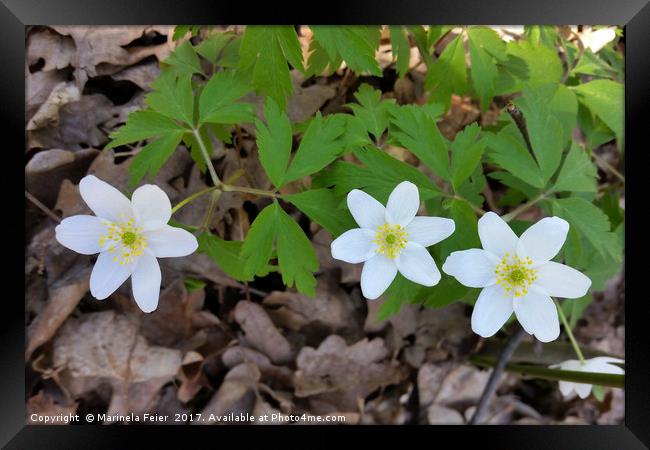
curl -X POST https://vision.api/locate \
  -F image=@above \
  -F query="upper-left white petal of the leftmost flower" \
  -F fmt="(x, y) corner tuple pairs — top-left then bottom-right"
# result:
(79, 175), (133, 222)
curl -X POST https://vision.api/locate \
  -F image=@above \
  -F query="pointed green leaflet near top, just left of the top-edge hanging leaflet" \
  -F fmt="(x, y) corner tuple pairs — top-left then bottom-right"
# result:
(425, 35), (467, 110)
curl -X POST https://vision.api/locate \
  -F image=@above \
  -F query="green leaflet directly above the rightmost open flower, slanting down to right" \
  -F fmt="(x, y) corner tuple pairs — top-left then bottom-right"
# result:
(487, 124), (545, 188)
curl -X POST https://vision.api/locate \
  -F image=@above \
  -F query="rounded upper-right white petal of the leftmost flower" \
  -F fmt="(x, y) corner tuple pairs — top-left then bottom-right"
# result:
(131, 184), (172, 231)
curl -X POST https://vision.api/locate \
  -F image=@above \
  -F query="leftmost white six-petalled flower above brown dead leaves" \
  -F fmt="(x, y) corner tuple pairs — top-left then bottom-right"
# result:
(55, 175), (198, 313)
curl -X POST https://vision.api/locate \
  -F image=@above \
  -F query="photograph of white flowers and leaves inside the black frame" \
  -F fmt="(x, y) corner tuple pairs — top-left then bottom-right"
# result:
(25, 24), (626, 426)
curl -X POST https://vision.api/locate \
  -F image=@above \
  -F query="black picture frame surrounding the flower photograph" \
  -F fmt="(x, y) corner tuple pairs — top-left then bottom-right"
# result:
(5, 0), (650, 450)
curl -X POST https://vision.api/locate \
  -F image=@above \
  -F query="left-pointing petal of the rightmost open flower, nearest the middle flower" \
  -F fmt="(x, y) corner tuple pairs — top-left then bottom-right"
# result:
(442, 248), (499, 287)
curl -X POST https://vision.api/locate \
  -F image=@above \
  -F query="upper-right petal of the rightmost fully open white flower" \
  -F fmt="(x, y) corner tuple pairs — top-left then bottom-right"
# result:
(517, 217), (569, 262)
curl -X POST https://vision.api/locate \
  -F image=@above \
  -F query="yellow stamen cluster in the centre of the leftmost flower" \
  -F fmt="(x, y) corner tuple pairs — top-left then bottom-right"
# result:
(99, 215), (147, 266)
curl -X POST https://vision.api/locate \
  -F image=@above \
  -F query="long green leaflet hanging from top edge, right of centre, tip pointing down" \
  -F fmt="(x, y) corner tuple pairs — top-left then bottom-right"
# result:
(467, 27), (506, 111)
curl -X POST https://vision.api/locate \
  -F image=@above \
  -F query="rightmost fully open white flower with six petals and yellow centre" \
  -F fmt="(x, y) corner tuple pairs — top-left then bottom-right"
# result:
(442, 212), (591, 342)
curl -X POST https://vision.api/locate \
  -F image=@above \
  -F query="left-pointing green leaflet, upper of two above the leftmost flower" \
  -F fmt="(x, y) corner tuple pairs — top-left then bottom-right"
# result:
(105, 111), (185, 149)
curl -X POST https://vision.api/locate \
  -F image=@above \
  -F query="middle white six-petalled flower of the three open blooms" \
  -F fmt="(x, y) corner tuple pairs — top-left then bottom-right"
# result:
(331, 181), (455, 300)
